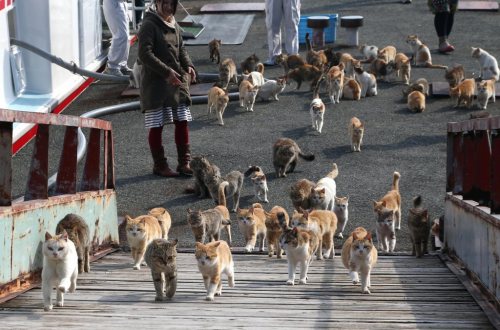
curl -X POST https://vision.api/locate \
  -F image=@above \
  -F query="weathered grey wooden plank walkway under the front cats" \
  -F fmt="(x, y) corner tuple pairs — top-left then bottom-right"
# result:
(0, 251), (494, 330)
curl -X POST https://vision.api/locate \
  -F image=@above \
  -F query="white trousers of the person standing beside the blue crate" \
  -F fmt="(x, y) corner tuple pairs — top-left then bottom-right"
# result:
(266, 0), (300, 59)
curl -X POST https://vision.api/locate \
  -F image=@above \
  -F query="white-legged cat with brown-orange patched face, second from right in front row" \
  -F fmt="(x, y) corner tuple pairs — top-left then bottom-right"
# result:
(280, 228), (320, 285)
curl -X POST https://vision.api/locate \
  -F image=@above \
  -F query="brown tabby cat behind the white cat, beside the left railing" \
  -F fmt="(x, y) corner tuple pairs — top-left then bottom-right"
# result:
(56, 213), (90, 274)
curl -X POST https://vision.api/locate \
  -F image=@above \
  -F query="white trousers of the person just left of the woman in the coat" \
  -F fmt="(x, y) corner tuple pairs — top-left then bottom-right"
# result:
(102, 0), (130, 69)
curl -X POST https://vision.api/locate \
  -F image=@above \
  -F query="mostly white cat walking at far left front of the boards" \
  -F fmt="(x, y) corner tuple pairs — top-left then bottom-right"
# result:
(42, 230), (78, 312)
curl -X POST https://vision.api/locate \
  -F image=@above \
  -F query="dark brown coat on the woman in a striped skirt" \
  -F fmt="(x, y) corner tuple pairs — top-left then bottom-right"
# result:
(138, 11), (193, 112)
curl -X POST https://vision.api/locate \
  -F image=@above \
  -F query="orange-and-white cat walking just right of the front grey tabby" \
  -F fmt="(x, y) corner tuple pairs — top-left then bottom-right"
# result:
(194, 241), (234, 301)
